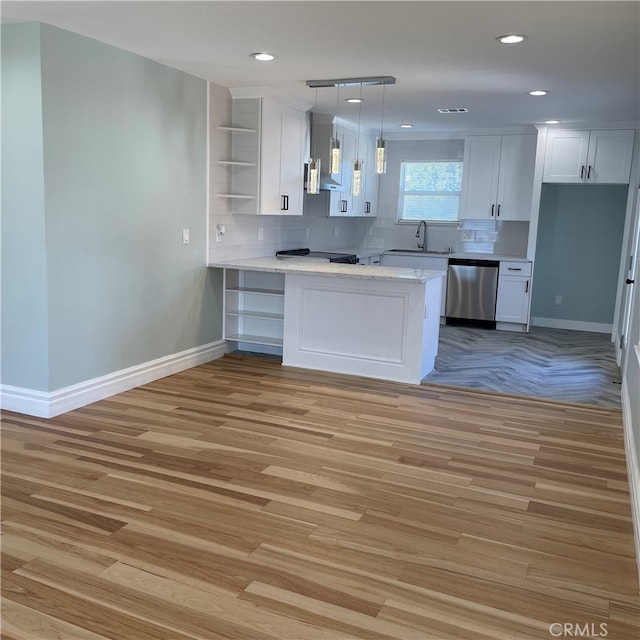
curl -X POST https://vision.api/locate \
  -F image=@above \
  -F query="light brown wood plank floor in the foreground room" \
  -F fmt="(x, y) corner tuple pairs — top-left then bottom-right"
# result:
(2, 357), (640, 640)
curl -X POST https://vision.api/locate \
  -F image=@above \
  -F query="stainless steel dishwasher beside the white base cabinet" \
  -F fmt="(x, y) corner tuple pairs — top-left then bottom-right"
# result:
(446, 258), (500, 329)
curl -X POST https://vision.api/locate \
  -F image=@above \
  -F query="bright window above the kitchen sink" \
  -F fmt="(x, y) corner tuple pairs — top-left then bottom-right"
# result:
(398, 160), (462, 222)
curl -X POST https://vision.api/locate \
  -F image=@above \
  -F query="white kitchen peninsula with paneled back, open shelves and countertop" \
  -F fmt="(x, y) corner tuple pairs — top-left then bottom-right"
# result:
(208, 257), (444, 384)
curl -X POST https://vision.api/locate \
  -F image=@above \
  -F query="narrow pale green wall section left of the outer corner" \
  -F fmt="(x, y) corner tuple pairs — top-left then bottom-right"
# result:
(1, 24), (49, 389)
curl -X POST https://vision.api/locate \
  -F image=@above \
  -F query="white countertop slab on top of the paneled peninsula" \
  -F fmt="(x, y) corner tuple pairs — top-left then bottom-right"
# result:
(207, 254), (444, 284)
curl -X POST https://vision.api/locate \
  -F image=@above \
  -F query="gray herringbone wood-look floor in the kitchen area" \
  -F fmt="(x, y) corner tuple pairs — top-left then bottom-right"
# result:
(425, 326), (620, 409)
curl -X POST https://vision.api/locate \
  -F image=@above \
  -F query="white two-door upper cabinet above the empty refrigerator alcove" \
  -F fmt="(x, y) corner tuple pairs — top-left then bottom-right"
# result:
(542, 129), (634, 184)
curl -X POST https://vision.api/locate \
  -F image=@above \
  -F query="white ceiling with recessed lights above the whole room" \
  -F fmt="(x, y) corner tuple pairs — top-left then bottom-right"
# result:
(1, 0), (640, 136)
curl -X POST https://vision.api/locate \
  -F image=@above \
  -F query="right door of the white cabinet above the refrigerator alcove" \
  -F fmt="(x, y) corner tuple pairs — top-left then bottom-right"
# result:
(585, 130), (634, 184)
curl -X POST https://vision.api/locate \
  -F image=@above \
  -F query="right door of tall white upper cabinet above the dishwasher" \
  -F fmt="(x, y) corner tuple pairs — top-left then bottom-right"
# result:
(495, 135), (537, 220)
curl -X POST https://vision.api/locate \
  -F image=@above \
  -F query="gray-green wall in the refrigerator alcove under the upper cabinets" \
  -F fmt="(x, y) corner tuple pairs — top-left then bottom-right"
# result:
(531, 184), (629, 324)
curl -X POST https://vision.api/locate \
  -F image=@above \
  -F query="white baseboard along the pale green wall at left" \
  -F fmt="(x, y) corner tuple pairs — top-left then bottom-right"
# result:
(0, 340), (229, 418)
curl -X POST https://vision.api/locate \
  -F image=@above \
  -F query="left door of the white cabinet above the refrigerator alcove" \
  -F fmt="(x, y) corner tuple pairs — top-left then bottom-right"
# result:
(542, 129), (589, 183)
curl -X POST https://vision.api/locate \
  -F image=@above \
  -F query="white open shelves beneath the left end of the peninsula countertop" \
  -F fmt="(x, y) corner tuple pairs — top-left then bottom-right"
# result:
(224, 269), (284, 353)
